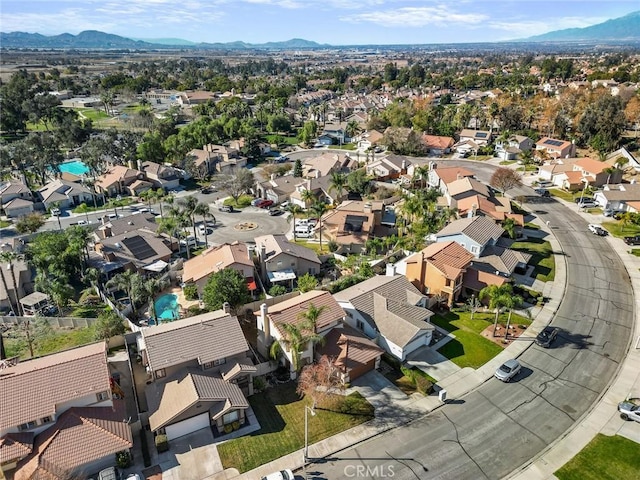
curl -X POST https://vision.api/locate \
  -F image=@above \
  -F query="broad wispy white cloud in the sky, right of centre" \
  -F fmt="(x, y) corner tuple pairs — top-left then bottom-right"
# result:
(340, 5), (489, 27)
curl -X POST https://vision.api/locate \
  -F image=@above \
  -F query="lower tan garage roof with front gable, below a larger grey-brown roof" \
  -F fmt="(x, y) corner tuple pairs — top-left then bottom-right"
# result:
(146, 369), (249, 431)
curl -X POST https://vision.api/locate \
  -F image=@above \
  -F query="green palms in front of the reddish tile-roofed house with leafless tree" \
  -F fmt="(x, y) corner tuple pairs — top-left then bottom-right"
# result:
(269, 303), (325, 373)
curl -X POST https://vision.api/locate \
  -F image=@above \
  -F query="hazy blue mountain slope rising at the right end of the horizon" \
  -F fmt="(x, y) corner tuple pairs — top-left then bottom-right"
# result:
(523, 11), (640, 42)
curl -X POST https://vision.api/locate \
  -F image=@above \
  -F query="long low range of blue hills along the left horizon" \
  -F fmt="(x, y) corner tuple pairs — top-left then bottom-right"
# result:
(0, 30), (327, 50)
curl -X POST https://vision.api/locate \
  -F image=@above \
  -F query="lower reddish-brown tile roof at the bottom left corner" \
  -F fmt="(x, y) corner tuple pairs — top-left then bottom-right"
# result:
(14, 400), (133, 480)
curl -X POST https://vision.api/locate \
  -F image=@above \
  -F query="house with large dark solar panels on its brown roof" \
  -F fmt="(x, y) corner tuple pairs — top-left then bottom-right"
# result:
(89, 229), (176, 276)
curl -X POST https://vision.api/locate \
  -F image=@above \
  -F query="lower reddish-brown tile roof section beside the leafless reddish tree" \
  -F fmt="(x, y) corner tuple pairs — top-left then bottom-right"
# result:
(318, 325), (384, 370)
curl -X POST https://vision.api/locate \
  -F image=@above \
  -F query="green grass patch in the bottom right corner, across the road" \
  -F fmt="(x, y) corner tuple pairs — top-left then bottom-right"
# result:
(555, 433), (640, 480)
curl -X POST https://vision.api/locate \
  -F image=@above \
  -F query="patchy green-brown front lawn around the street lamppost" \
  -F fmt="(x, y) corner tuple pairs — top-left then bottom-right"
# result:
(218, 385), (372, 473)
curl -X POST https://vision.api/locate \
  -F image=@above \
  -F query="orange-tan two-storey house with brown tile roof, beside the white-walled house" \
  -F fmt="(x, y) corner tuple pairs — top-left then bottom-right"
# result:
(406, 241), (473, 306)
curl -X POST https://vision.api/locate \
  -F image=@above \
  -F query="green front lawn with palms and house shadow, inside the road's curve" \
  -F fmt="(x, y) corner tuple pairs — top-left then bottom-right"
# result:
(430, 312), (531, 368)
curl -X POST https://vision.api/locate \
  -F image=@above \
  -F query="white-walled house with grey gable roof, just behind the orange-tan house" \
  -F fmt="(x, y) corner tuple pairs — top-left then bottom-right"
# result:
(436, 216), (504, 258)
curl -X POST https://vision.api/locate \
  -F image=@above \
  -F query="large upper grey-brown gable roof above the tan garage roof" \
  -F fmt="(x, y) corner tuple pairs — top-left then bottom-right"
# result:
(141, 310), (249, 370)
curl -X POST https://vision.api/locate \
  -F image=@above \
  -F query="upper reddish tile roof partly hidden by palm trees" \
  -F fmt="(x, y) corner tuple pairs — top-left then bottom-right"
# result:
(256, 290), (345, 334)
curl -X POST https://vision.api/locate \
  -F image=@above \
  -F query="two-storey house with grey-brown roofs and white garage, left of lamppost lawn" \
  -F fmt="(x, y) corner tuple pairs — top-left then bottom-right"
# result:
(137, 310), (257, 441)
